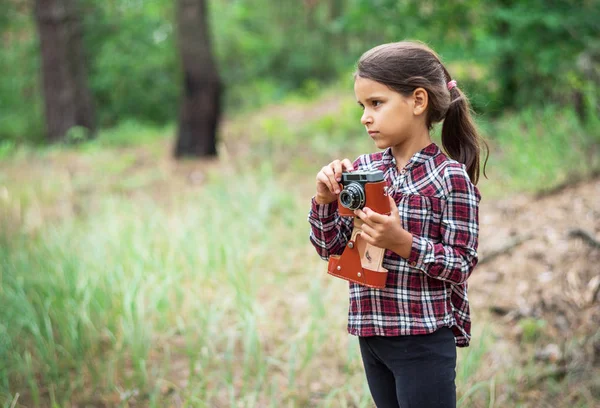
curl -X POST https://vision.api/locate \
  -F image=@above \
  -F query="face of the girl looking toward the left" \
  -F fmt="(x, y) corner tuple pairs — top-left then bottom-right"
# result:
(354, 77), (421, 149)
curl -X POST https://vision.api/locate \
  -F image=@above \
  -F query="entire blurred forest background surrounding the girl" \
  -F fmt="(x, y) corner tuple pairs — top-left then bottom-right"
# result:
(0, 0), (600, 408)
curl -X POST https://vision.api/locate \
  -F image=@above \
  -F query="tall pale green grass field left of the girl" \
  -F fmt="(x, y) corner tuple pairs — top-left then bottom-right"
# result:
(0, 155), (492, 407)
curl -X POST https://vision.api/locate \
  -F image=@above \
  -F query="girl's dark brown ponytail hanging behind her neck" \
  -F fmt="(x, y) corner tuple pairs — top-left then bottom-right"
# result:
(442, 82), (489, 184)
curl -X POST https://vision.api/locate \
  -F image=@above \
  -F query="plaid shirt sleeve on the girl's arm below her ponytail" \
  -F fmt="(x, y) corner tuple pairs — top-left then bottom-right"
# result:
(408, 166), (481, 284)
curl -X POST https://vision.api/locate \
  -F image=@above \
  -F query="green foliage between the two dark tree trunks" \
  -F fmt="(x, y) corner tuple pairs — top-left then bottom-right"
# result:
(83, 0), (179, 126)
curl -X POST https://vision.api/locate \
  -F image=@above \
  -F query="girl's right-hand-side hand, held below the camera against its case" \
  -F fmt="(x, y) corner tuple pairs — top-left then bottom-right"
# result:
(354, 196), (412, 258)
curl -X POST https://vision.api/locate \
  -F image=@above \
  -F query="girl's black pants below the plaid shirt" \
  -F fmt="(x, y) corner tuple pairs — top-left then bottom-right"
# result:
(359, 327), (456, 408)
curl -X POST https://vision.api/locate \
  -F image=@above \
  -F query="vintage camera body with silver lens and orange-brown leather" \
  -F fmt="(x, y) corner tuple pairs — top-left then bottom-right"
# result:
(338, 170), (390, 216)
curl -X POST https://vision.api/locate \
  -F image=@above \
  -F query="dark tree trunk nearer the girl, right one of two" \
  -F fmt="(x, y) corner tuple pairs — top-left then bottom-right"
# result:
(175, 0), (222, 157)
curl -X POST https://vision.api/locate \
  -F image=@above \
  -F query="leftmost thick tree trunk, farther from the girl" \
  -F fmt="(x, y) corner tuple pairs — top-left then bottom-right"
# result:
(35, 0), (95, 141)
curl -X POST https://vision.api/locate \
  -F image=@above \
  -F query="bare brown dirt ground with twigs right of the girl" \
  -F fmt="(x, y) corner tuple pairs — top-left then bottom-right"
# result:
(469, 178), (600, 406)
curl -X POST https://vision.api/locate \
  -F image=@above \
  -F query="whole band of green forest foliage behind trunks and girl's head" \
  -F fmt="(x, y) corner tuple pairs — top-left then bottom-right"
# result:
(0, 0), (600, 141)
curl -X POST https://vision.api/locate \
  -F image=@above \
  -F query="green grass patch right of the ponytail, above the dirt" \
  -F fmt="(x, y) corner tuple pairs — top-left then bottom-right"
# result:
(480, 106), (600, 195)
